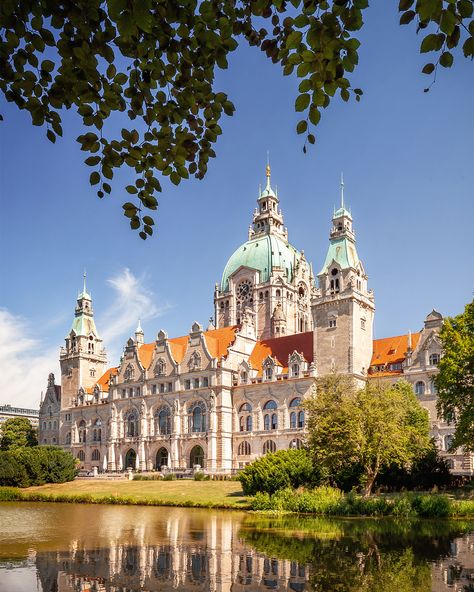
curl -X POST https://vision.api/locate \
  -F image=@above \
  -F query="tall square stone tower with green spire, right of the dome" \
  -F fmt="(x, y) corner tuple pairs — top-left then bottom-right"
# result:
(311, 176), (375, 380)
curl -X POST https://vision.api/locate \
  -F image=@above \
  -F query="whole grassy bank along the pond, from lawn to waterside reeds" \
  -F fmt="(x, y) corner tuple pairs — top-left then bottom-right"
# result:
(0, 479), (474, 518)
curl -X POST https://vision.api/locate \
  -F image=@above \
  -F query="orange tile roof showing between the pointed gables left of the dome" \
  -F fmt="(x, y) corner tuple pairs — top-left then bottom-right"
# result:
(138, 325), (238, 369)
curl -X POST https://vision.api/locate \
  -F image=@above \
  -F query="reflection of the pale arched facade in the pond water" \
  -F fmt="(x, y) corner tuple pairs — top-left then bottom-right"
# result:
(36, 513), (309, 592)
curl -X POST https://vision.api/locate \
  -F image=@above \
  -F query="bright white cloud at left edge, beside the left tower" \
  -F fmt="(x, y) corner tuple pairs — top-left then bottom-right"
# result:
(0, 308), (59, 409)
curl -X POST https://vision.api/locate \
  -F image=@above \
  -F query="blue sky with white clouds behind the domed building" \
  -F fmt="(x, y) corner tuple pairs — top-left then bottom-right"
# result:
(0, 2), (474, 405)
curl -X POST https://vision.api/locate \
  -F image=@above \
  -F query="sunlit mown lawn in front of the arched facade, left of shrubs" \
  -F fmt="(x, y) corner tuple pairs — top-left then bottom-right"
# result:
(11, 479), (248, 509)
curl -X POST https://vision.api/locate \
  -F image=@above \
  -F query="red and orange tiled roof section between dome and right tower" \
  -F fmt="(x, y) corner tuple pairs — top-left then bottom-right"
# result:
(249, 331), (313, 370)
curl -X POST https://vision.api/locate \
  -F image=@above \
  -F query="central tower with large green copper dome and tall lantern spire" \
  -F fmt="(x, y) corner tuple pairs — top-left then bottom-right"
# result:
(214, 165), (314, 339)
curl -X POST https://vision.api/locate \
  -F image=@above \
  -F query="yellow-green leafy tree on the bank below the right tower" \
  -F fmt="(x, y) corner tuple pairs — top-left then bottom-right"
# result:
(306, 374), (430, 495)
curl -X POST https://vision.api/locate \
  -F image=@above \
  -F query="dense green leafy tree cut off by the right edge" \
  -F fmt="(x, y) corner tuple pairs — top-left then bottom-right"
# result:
(435, 300), (474, 452)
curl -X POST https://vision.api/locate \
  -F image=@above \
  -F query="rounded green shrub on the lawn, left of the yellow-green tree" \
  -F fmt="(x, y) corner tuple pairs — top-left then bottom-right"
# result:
(238, 449), (319, 495)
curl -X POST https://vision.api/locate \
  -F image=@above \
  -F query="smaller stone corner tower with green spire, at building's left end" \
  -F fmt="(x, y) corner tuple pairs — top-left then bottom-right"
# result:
(59, 273), (107, 409)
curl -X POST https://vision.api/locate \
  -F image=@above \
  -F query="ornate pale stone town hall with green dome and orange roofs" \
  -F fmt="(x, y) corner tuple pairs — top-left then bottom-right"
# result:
(40, 167), (474, 474)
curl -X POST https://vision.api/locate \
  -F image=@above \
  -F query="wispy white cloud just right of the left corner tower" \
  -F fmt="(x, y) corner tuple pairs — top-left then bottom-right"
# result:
(97, 267), (170, 363)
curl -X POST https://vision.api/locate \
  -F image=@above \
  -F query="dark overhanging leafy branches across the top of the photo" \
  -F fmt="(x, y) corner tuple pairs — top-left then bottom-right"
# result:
(0, 0), (474, 239)
